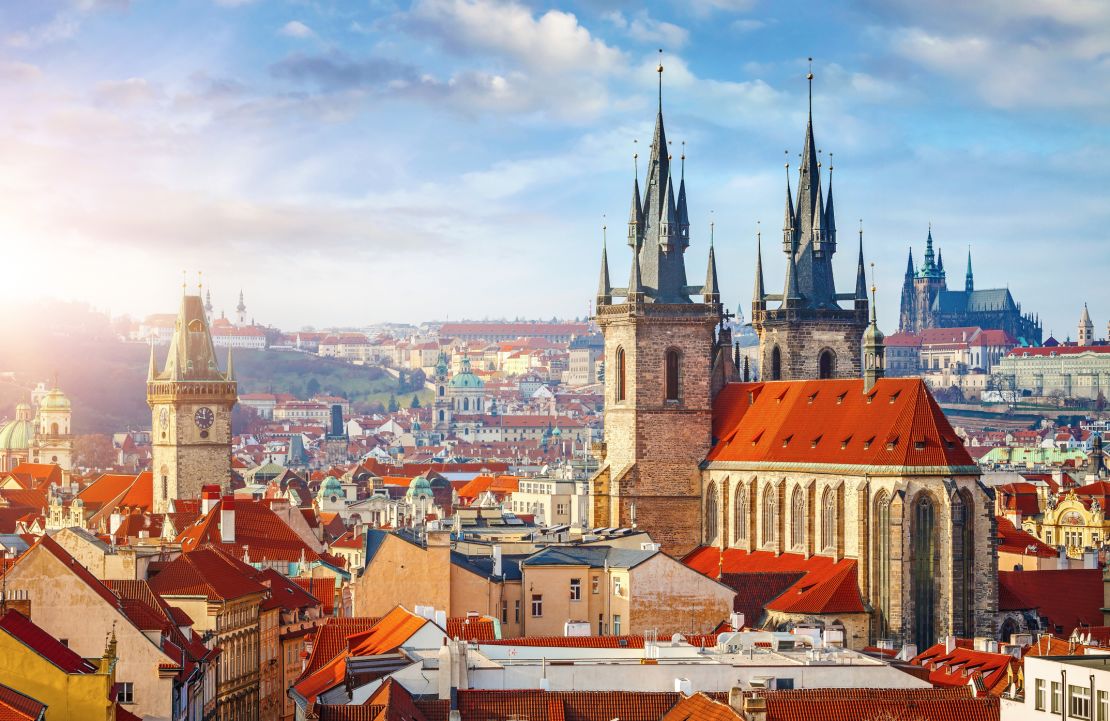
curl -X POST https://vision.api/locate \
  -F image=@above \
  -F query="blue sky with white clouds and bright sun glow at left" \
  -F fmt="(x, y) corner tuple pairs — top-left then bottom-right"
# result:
(0, 0), (1110, 330)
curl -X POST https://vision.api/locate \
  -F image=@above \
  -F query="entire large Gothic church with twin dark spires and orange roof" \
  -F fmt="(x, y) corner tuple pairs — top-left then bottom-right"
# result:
(589, 67), (998, 648)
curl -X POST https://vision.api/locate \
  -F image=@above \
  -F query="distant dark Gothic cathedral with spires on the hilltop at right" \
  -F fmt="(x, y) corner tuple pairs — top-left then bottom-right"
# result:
(898, 230), (1042, 346)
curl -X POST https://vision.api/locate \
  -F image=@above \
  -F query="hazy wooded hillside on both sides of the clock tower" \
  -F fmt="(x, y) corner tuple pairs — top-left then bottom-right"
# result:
(0, 334), (431, 434)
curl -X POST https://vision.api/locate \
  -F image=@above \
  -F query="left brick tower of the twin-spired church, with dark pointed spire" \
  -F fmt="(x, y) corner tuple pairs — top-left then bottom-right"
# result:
(589, 64), (735, 554)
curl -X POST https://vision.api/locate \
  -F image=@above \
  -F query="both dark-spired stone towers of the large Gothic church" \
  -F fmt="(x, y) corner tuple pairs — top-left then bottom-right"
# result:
(591, 65), (882, 548)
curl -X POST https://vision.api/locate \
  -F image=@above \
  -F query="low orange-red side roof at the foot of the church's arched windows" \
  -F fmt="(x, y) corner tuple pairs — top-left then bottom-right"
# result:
(683, 546), (865, 622)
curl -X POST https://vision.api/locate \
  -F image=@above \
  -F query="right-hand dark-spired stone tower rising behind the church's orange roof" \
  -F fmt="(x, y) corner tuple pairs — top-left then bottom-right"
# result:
(751, 68), (867, 380)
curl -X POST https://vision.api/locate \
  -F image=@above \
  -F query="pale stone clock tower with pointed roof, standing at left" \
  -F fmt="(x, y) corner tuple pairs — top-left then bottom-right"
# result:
(147, 295), (238, 512)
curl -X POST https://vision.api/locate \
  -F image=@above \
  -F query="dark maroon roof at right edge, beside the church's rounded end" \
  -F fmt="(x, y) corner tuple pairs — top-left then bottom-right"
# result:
(998, 568), (1103, 636)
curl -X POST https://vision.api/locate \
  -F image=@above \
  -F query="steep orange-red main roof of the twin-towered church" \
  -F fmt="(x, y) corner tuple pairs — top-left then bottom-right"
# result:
(708, 378), (975, 467)
